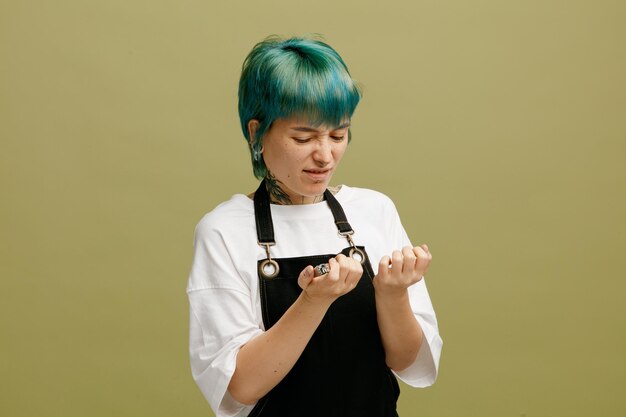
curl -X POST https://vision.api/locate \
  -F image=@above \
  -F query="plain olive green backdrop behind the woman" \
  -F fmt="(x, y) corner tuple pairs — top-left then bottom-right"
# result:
(0, 0), (626, 417)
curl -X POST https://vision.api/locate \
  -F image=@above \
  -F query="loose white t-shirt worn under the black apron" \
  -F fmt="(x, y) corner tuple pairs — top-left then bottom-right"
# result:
(187, 185), (442, 417)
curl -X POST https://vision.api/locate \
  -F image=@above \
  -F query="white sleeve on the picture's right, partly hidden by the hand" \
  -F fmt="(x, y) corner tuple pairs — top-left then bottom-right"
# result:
(388, 200), (443, 387)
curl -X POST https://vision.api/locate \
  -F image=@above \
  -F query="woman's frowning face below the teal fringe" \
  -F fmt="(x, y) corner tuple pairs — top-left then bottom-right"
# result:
(254, 118), (350, 204)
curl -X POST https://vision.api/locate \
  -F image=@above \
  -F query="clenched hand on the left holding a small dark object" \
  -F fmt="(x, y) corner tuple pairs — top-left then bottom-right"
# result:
(298, 254), (363, 305)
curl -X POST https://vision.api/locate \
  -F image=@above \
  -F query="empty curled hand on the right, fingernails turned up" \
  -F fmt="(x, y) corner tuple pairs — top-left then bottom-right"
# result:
(374, 244), (433, 296)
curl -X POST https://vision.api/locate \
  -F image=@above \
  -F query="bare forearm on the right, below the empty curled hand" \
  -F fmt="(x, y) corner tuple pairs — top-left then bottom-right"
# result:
(376, 290), (424, 371)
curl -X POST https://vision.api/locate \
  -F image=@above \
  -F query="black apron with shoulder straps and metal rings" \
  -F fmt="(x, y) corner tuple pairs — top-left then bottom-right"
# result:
(249, 181), (400, 417)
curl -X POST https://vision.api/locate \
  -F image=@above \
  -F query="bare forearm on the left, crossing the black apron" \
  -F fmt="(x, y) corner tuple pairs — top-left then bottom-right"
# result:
(228, 292), (330, 404)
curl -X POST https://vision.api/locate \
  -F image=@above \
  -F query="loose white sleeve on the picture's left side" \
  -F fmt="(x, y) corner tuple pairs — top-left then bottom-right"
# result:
(187, 214), (262, 417)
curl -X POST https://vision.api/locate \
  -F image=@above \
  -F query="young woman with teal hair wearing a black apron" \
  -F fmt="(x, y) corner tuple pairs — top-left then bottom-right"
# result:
(187, 37), (442, 417)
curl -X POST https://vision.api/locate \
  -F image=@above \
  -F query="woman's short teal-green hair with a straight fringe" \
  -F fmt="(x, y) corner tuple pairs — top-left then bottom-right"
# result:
(239, 35), (361, 179)
